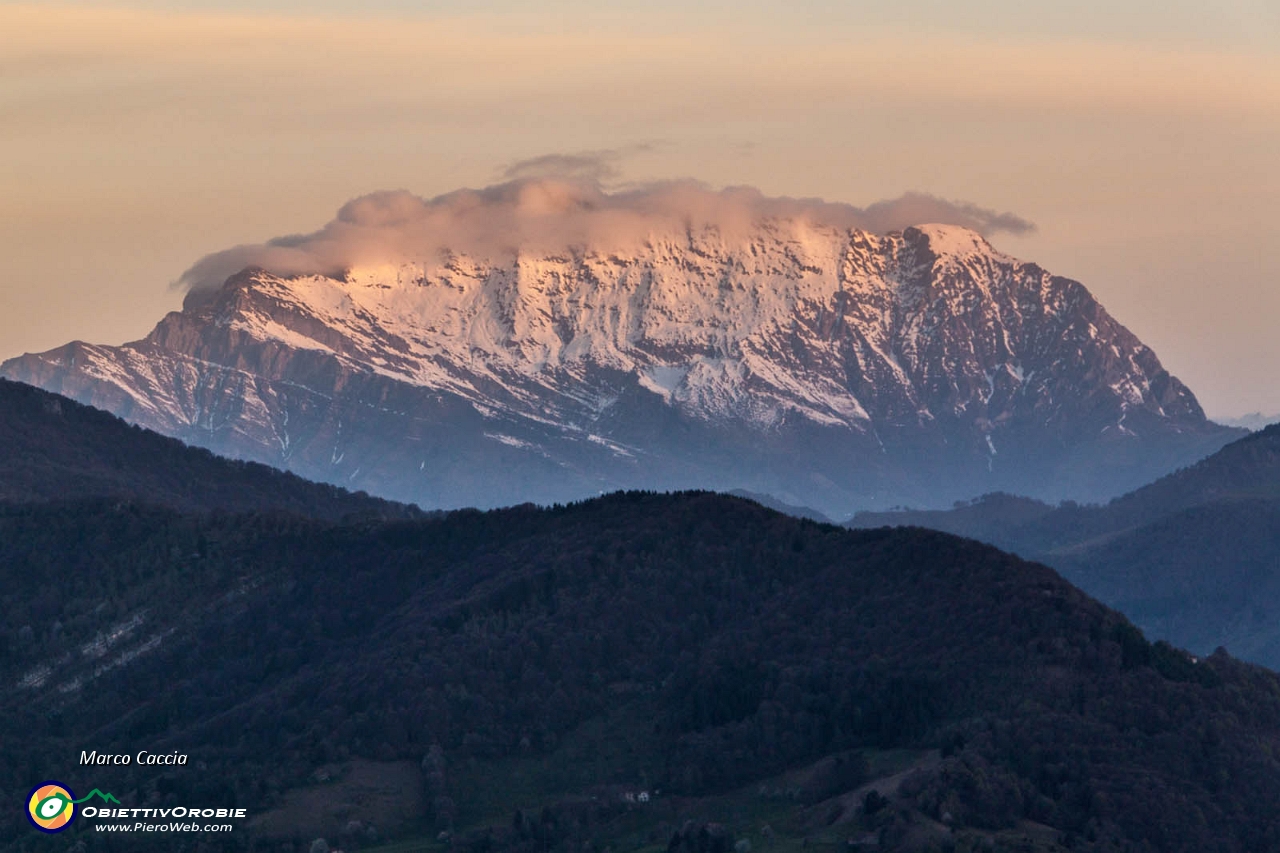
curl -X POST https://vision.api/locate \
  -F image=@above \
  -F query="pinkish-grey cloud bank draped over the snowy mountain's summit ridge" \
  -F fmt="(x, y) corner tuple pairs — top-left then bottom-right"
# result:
(178, 175), (1034, 302)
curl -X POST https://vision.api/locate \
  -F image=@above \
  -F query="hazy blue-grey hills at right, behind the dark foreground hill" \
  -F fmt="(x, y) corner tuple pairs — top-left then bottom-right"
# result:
(851, 425), (1280, 667)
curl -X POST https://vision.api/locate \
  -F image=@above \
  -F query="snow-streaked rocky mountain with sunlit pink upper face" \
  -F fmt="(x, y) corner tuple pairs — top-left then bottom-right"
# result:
(0, 219), (1235, 516)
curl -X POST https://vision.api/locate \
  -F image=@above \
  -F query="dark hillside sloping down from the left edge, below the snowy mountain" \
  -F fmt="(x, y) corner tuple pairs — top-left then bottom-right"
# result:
(0, 379), (417, 520)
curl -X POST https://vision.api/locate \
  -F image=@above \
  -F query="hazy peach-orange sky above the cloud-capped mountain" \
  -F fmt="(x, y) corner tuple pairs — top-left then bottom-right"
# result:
(0, 0), (1280, 416)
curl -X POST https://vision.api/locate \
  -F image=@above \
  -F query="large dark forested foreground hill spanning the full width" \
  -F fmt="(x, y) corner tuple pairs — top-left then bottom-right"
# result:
(0, 493), (1280, 853)
